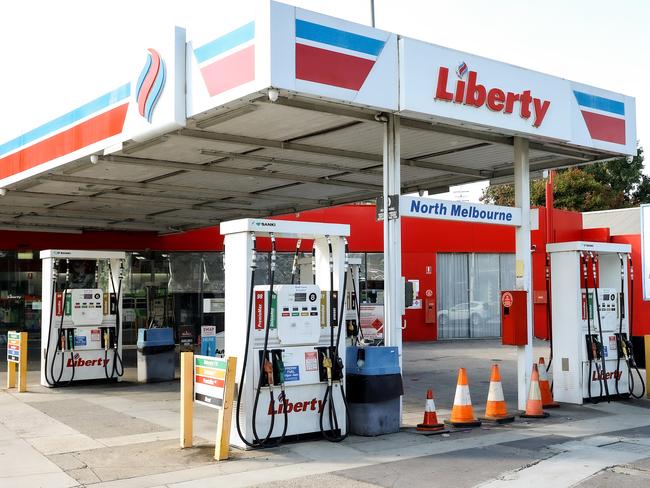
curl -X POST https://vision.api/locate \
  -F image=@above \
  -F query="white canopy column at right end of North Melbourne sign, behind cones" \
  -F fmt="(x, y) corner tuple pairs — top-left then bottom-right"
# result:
(514, 137), (533, 410)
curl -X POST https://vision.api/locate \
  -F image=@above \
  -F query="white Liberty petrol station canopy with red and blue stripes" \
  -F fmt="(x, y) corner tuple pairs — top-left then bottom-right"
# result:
(0, 2), (636, 232)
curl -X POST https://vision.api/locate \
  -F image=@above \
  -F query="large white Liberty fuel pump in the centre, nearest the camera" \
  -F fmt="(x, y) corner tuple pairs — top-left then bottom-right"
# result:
(221, 219), (349, 448)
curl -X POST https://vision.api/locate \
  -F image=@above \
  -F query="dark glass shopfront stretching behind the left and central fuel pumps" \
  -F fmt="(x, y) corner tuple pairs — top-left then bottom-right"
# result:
(0, 251), (383, 346)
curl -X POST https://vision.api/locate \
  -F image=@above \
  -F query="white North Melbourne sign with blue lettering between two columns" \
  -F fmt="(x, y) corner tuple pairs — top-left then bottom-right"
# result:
(399, 196), (521, 226)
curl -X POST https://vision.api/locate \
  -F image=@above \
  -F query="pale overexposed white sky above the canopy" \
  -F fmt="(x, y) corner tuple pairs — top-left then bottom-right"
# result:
(0, 0), (650, 200)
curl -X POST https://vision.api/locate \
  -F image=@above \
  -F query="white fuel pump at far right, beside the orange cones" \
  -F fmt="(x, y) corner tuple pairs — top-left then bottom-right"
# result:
(547, 241), (630, 404)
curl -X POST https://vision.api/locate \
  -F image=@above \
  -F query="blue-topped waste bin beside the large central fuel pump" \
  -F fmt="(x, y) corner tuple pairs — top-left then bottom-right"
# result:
(345, 346), (404, 436)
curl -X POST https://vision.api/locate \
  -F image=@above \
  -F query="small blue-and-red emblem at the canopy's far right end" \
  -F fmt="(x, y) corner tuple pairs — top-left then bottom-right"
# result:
(573, 90), (625, 144)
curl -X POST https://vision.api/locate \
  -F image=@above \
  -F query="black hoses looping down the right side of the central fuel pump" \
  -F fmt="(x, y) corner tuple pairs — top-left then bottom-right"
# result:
(319, 236), (350, 442)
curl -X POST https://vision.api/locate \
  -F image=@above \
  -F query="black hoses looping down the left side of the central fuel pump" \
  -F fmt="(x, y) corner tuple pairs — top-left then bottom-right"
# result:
(252, 233), (288, 447)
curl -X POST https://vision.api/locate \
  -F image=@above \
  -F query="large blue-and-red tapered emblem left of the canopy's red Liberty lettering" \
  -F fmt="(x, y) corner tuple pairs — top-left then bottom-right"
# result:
(296, 19), (386, 91)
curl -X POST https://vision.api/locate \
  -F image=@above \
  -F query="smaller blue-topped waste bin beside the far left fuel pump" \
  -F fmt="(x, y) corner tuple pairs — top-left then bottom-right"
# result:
(137, 327), (176, 383)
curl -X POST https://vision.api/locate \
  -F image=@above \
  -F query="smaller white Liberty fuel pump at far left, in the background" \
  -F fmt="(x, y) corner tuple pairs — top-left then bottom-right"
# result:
(41, 250), (126, 387)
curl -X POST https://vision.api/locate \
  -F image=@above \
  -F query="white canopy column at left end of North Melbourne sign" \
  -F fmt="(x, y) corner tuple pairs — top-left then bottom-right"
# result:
(383, 115), (403, 367)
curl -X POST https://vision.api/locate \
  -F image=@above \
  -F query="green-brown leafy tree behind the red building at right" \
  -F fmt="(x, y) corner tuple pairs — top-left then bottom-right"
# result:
(481, 147), (650, 212)
